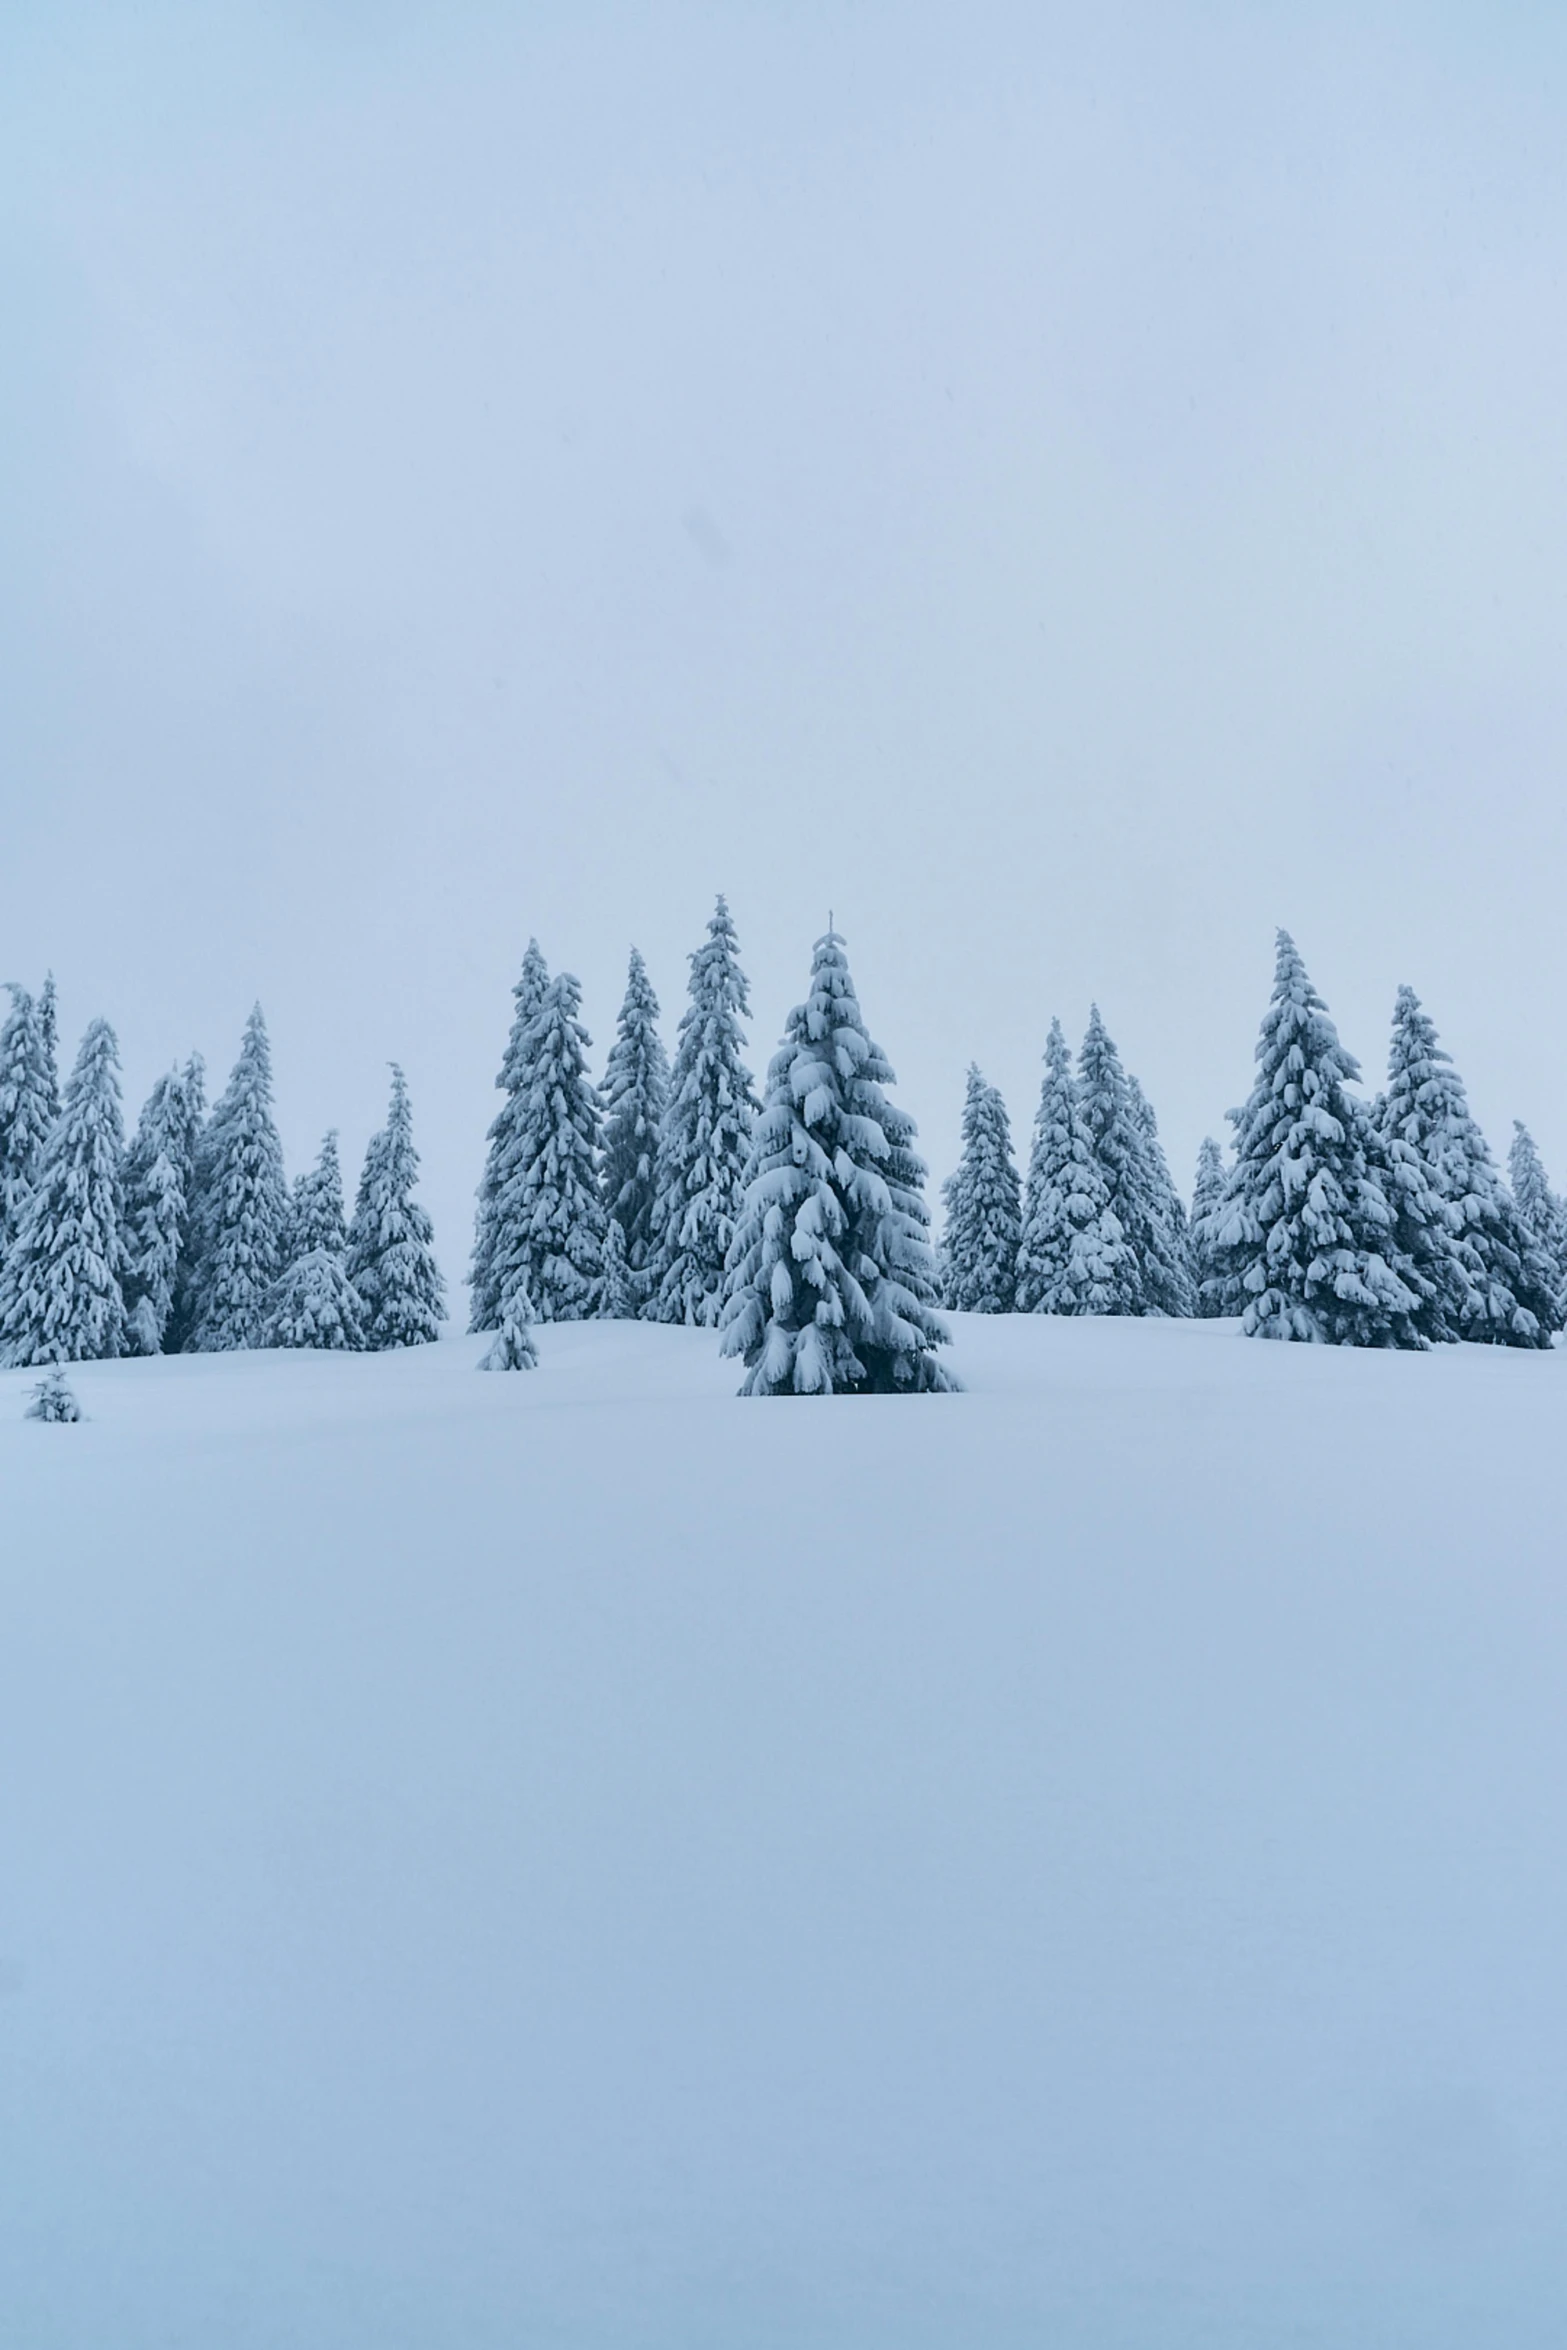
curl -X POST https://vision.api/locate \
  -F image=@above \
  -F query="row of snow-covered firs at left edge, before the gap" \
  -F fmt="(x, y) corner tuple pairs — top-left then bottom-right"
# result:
(0, 985), (444, 1363)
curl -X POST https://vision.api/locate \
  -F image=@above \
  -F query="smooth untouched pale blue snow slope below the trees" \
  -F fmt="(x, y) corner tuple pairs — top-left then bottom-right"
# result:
(0, 1321), (1567, 2350)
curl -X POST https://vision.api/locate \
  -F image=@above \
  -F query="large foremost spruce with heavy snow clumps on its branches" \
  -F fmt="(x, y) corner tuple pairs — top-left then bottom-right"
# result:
(721, 931), (956, 1396)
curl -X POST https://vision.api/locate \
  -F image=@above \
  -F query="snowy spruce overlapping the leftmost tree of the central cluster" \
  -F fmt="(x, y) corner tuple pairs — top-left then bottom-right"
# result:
(493, 971), (604, 1321)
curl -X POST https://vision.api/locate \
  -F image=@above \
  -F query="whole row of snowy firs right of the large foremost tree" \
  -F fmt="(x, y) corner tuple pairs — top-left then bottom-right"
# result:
(942, 933), (1567, 1347)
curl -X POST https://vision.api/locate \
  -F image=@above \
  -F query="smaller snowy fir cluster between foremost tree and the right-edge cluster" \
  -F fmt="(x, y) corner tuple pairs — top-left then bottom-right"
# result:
(942, 1003), (1196, 1314)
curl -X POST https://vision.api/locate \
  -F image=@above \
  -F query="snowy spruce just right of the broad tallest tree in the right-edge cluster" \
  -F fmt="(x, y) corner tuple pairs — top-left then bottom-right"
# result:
(1377, 987), (1558, 1347)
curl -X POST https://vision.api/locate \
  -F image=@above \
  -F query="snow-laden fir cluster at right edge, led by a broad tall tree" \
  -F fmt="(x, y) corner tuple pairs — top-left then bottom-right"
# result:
(1191, 931), (1567, 1347)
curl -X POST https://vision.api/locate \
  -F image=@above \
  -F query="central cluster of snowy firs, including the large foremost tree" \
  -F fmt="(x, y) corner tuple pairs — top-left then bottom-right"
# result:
(470, 898), (951, 1394)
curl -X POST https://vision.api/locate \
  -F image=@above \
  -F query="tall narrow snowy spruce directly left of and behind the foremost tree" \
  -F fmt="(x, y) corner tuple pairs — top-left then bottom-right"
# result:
(648, 898), (756, 1328)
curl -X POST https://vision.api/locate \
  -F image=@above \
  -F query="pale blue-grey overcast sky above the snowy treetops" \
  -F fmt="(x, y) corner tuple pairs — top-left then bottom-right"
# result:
(0, 0), (1567, 1304)
